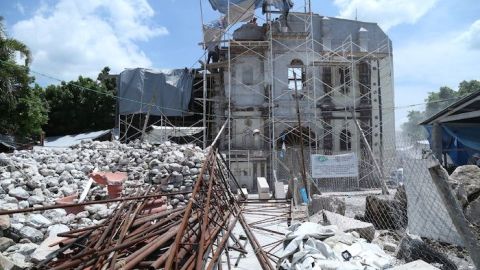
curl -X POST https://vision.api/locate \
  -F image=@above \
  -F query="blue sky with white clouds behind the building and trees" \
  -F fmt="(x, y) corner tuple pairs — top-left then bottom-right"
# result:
(0, 0), (480, 128)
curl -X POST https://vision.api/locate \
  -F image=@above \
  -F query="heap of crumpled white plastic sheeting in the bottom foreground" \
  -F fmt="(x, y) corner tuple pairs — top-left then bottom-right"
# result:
(278, 222), (394, 270)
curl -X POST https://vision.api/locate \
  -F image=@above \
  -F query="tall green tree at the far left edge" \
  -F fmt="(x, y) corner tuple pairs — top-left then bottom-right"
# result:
(0, 17), (47, 138)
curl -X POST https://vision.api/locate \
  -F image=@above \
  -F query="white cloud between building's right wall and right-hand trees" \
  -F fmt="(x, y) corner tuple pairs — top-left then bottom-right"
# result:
(393, 21), (480, 125)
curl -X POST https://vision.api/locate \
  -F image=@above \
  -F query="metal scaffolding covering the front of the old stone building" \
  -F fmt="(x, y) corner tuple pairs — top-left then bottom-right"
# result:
(216, 0), (394, 194)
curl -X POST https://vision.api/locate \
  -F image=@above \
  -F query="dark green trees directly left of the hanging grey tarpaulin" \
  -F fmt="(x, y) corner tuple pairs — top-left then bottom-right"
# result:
(45, 67), (116, 136)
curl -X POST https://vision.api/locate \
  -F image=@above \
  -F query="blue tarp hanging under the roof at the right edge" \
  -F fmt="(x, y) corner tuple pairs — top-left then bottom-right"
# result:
(425, 123), (480, 166)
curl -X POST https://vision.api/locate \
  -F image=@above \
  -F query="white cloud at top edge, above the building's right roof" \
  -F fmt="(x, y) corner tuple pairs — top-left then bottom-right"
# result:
(334, 0), (438, 31)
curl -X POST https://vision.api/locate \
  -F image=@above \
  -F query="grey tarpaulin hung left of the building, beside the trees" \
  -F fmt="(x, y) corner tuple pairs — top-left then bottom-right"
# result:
(118, 68), (193, 116)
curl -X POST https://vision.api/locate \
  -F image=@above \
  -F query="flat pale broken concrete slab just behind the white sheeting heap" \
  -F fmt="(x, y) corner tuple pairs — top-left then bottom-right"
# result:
(322, 210), (375, 241)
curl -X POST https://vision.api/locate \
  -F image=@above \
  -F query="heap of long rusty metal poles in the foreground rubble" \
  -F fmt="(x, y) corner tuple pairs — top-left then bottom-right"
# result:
(30, 134), (244, 270)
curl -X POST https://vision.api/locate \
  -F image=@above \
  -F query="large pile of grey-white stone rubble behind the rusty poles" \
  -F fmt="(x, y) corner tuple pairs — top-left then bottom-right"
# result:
(0, 141), (206, 269)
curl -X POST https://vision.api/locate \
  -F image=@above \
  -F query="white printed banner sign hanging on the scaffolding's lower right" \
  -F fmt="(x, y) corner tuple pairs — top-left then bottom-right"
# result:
(311, 153), (358, 178)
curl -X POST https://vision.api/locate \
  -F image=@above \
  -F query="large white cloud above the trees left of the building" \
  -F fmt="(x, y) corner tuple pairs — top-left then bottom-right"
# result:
(13, 0), (168, 80)
